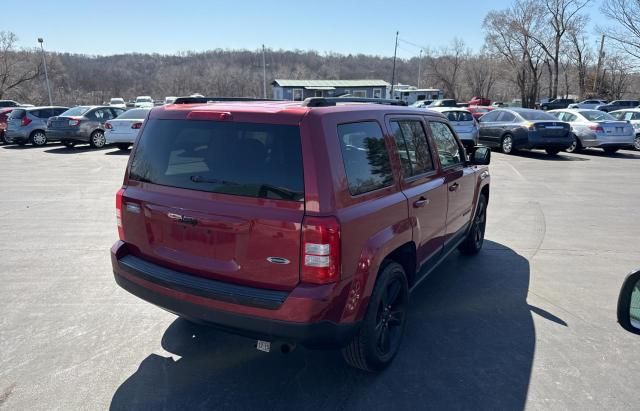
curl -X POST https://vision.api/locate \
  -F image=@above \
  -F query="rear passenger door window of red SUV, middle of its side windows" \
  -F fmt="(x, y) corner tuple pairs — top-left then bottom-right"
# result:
(390, 120), (434, 178)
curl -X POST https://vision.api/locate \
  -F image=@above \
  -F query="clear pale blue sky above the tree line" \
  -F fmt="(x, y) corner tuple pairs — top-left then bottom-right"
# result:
(7, 0), (601, 58)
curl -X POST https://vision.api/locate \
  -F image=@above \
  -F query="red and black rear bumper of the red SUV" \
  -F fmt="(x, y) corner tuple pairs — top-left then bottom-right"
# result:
(111, 241), (359, 348)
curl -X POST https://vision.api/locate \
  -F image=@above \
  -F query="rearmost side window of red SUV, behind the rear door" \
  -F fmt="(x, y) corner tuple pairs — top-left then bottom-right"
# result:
(338, 121), (393, 195)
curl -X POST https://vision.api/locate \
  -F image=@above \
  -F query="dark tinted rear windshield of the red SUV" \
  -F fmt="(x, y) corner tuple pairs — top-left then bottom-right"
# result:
(129, 120), (304, 201)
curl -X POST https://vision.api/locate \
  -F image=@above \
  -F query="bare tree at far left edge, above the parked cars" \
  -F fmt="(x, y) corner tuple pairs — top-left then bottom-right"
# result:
(0, 31), (41, 98)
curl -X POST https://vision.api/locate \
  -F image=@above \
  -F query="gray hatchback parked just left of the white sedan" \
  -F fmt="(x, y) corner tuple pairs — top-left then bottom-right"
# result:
(47, 106), (124, 148)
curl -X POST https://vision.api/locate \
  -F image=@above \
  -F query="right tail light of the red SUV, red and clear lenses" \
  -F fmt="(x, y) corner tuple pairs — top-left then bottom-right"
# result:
(301, 217), (340, 284)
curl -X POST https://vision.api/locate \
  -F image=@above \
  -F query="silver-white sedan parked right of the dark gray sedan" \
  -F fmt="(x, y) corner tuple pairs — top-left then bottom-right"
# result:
(549, 109), (636, 154)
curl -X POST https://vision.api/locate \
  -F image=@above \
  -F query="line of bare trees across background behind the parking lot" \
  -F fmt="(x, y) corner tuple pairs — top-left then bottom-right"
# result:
(0, 0), (640, 107)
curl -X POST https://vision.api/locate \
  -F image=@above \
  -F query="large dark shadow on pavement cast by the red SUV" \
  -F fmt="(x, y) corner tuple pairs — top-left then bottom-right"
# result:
(110, 241), (544, 410)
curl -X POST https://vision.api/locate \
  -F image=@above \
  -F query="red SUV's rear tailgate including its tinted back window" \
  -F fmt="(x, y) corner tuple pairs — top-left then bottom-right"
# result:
(122, 119), (304, 290)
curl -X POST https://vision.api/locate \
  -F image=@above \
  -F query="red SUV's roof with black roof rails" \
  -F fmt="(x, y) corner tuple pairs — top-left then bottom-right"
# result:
(149, 101), (455, 123)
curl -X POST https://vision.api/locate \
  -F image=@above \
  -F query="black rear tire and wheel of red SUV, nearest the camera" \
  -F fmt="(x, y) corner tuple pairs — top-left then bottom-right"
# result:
(342, 262), (409, 371)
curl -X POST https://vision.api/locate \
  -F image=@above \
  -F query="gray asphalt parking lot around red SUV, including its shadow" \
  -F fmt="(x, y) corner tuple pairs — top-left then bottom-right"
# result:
(0, 145), (640, 410)
